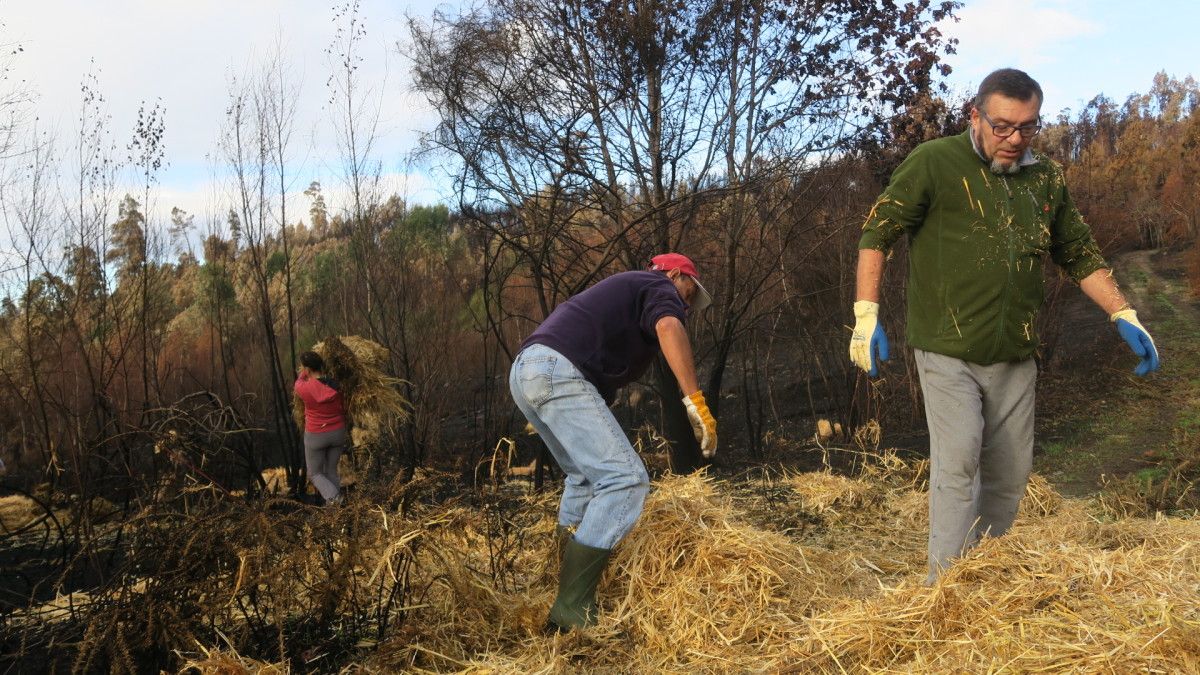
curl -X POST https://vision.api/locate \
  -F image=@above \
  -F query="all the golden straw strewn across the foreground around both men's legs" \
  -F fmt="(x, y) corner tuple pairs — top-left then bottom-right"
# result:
(171, 453), (1200, 673)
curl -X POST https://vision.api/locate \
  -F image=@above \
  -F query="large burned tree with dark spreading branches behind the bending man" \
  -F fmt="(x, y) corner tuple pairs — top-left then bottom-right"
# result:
(410, 0), (956, 470)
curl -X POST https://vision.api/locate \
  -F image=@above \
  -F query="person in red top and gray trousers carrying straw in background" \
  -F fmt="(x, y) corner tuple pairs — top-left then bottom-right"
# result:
(294, 352), (349, 504)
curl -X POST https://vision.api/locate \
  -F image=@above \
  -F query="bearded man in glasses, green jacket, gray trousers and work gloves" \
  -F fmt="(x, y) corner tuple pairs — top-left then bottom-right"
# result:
(850, 68), (1158, 584)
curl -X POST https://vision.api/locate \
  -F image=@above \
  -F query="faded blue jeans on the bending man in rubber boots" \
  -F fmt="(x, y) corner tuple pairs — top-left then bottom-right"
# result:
(509, 345), (650, 549)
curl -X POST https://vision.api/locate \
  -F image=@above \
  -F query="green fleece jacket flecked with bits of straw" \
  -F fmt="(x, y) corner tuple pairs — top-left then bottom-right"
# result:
(858, 129), (1108, 364)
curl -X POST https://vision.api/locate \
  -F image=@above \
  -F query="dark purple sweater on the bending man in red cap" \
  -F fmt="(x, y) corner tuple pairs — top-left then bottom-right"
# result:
(521, 271), (688, 404)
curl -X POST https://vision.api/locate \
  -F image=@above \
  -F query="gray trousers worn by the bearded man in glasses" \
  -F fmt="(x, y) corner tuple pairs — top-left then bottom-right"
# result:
(916, 350), (1038, 583)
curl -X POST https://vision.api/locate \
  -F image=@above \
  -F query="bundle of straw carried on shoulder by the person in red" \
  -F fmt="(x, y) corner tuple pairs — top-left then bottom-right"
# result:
(293, 335), (409, 448)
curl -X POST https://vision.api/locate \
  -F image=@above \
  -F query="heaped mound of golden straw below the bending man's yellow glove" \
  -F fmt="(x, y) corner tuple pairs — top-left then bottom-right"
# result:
(600, 474), (846, 673)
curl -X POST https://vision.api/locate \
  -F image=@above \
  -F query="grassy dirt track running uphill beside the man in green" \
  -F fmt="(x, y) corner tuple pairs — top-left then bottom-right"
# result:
(1034, 246), (1200, 496)
